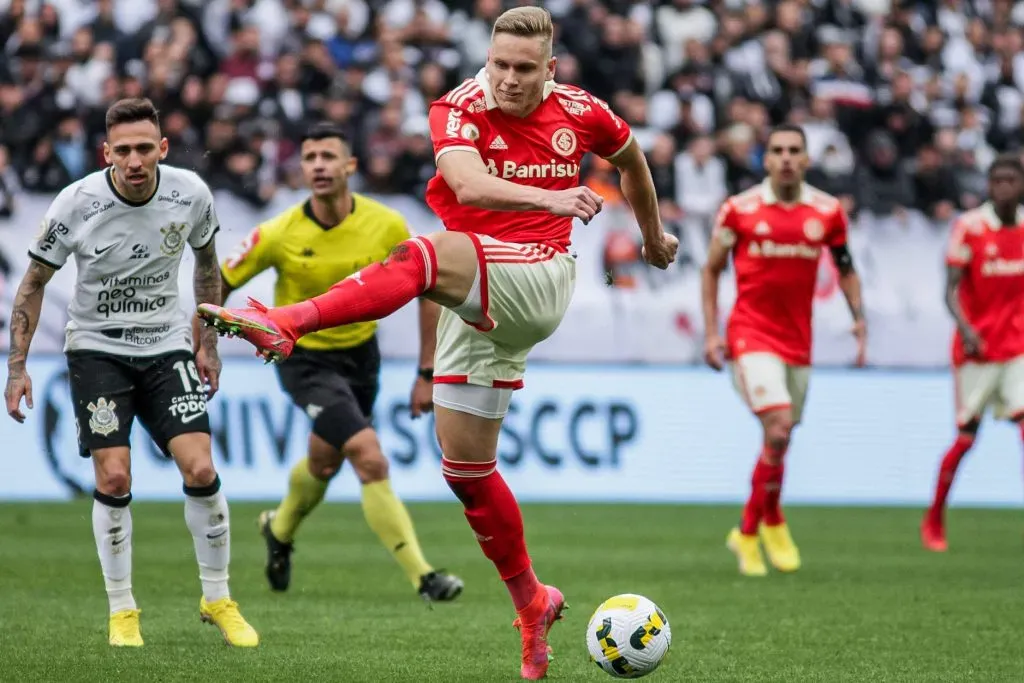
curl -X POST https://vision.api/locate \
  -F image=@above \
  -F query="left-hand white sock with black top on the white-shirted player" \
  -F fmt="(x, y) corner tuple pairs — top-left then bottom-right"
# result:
(92, 490), (135, 614)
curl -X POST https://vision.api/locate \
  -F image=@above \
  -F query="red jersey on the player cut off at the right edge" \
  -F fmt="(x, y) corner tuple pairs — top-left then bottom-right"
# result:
(946, 204), (1024, 366)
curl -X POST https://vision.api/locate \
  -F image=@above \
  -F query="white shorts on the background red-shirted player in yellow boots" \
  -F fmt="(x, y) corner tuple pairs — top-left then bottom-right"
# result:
(729, 351), (811, 424)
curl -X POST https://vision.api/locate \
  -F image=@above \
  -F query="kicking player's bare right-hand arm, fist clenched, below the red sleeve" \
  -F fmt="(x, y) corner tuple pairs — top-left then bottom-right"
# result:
(608, 138), (679, 269)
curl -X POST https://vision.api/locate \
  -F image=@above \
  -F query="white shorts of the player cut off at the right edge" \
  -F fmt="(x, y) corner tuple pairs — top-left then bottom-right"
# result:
(953, 355), (1024, 427)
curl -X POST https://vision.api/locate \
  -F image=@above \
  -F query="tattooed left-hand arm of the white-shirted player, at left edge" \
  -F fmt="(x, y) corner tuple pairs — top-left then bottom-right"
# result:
(3, 260), (56, 422)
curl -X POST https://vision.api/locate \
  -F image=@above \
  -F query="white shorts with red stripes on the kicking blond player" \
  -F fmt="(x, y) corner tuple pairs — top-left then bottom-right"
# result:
(434, 233), (575, 401)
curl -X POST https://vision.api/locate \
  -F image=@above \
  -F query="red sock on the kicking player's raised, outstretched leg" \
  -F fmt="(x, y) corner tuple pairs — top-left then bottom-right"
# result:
(273, 238), (437, 338)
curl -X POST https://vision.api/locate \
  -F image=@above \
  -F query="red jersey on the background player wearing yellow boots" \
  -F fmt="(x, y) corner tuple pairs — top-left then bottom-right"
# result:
(713, 180), (848, 366)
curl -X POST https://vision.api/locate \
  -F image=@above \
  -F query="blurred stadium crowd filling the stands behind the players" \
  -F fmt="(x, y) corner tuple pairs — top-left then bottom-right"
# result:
(0, 0), (1024, 222)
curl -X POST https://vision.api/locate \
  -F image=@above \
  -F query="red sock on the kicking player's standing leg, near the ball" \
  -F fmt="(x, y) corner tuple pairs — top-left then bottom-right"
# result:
(441, 458), (542, 610)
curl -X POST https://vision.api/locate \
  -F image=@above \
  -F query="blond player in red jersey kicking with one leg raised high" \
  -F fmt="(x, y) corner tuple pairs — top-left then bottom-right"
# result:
(200, 7), (678, 680)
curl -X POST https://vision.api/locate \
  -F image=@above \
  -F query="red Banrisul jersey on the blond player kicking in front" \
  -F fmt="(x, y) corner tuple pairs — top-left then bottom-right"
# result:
(426, 70), (632, 251)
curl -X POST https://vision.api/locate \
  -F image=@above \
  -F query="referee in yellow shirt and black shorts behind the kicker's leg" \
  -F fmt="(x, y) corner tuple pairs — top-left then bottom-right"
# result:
(221, 124), (463, 601)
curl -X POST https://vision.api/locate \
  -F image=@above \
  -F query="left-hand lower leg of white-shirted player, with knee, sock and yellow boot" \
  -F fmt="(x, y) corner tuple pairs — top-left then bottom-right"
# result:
(92, 446), (142, 647)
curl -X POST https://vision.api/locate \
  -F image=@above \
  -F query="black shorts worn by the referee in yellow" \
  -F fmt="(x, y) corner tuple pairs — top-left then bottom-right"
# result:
(275, 337), (381, 450)
